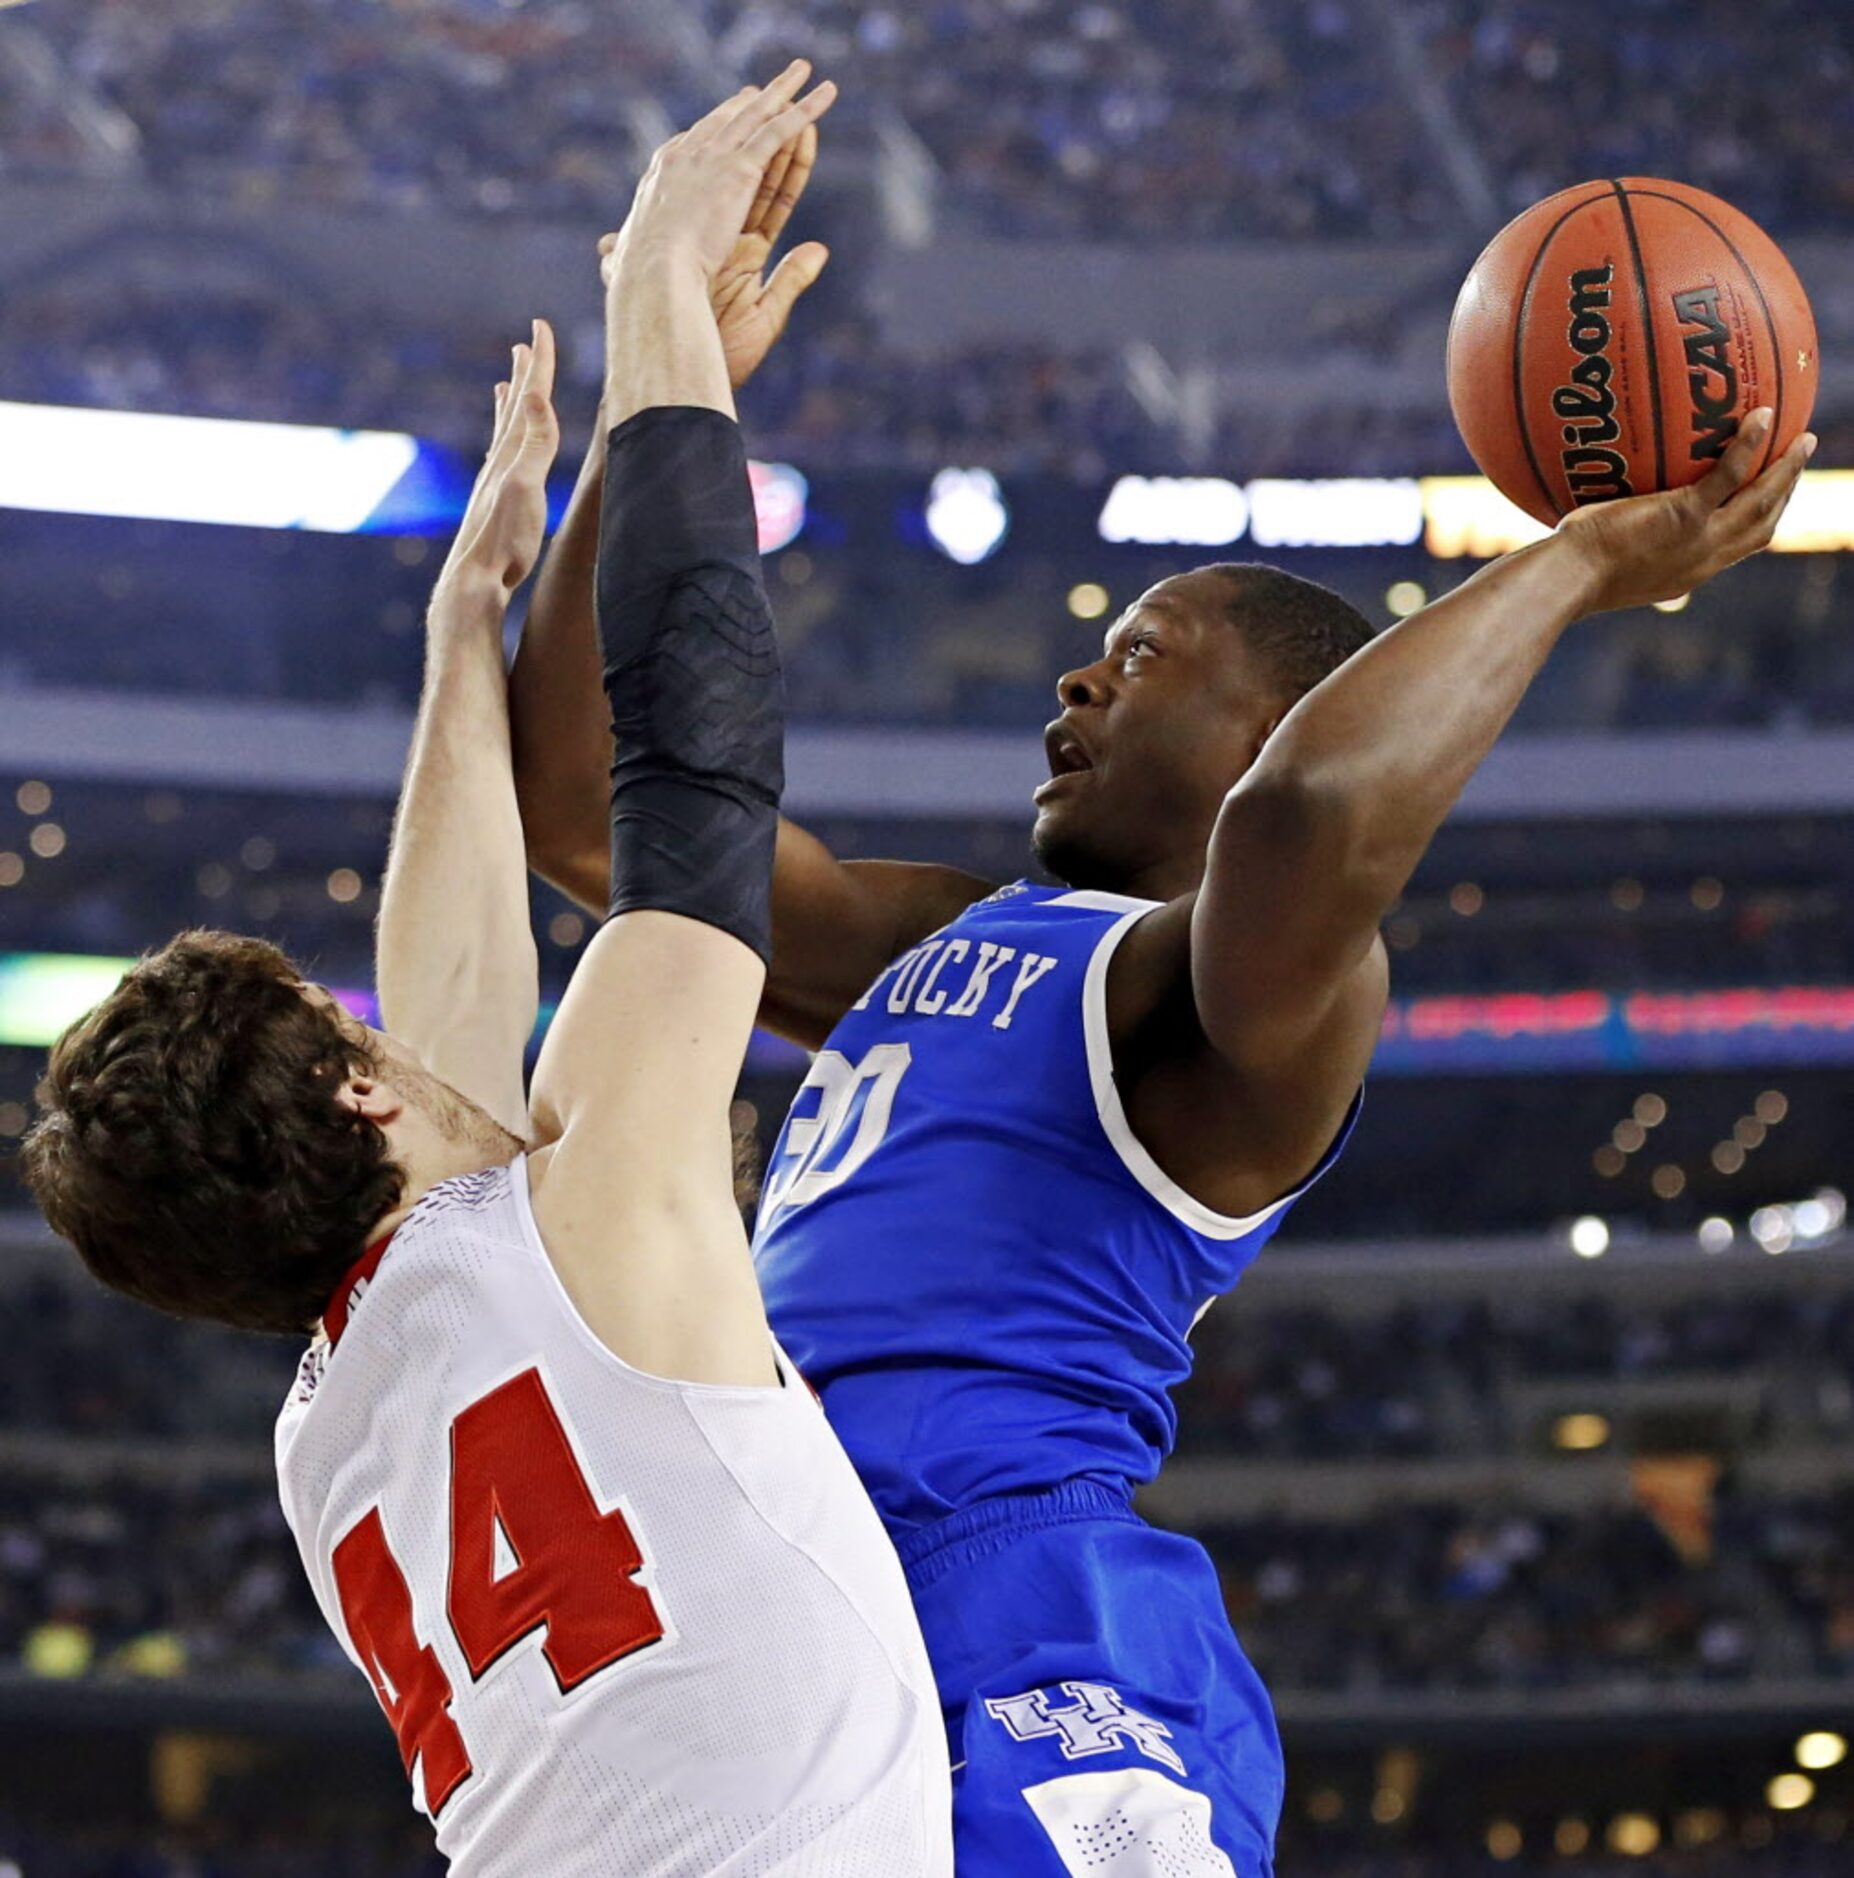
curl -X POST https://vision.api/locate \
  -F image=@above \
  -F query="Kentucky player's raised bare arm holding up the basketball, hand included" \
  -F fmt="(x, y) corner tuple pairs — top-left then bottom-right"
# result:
(1155, 409), (1813, 1170)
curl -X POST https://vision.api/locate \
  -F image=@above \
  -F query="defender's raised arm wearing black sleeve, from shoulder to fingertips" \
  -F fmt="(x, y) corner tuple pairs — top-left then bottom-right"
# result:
(532, 64), (834, 1382)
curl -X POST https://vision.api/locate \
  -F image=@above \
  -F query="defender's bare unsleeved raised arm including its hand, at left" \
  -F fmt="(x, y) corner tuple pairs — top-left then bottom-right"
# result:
(376, 321), (558, 1136)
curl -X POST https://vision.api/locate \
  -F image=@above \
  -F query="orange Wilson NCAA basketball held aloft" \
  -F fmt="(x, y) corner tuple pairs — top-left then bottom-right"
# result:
(1448, 177), (1818, 524)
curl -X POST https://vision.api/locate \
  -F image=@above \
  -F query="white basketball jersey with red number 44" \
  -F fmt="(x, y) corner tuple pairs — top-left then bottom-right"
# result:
(276, 1157), (952, 1878)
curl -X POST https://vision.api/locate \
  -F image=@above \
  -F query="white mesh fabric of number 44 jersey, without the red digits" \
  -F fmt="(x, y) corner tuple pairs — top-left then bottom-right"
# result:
(276, 1161), (952, 1878)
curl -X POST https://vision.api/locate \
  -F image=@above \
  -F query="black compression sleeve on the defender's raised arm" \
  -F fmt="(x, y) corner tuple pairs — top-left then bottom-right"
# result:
(597, 406), (785, 960)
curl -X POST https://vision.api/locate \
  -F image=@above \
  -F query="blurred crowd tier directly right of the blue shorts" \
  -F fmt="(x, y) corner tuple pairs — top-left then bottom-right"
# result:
(1200, 1491), (1854, 1692)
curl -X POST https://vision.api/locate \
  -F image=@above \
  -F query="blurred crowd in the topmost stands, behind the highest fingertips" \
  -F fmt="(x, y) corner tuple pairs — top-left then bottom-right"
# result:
(18, 0), (1854, 240)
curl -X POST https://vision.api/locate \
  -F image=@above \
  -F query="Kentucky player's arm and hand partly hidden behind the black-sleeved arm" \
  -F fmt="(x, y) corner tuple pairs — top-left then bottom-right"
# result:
(509, 113), (990, 1046)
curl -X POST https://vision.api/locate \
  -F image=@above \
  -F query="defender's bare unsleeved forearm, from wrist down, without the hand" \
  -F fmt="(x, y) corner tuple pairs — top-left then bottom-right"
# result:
(376, 573), (539, 1136)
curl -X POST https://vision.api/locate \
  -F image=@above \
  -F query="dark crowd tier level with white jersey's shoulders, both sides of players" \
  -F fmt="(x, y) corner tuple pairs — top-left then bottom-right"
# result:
(14, 1273), (1854, 1457)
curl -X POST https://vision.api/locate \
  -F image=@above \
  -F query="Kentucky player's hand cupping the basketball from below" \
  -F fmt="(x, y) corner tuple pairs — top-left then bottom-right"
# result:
(1557, 406), (1815, 612)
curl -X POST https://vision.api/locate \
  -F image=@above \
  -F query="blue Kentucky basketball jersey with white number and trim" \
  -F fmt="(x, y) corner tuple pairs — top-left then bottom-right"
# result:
(755, 883), (1337, 1534)
